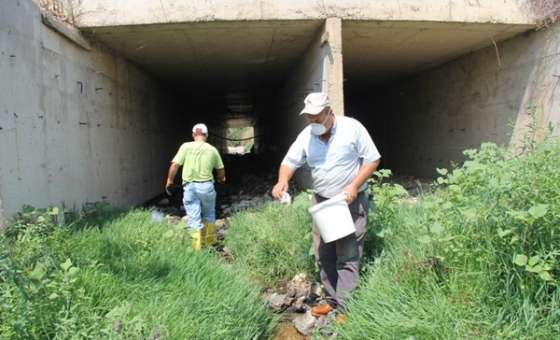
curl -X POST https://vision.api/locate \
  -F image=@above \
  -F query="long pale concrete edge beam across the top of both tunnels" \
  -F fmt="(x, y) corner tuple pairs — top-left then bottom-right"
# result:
(74, 0), (532, 27)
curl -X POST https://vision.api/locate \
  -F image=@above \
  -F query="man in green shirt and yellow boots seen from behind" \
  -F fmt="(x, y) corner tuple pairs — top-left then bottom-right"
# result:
(165, 123), (226, 251)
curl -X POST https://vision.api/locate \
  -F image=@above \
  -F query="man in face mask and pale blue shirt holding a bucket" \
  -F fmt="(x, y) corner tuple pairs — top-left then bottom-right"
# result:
(272, 93), (381, 316)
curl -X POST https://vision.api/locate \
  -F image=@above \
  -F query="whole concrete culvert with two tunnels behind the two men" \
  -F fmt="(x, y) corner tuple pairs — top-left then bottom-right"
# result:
(0, 0), (560, 215)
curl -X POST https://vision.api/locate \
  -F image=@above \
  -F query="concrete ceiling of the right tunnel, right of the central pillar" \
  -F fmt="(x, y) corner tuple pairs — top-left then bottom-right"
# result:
(342, 21), (531, 85)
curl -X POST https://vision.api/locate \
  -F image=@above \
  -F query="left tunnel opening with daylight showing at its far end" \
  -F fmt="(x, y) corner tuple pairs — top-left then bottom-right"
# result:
(86, 20), (323, 216)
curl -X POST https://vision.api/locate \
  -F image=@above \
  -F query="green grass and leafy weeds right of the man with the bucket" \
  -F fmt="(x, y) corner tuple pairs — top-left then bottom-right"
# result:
(336, 140), (560, 339)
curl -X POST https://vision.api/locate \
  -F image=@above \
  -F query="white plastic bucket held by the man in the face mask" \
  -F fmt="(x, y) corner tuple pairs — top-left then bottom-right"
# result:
(309, 194), (356, 243)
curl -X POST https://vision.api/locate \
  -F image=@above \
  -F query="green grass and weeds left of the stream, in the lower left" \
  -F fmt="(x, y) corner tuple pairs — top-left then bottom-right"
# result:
(0, 206), (275, 339)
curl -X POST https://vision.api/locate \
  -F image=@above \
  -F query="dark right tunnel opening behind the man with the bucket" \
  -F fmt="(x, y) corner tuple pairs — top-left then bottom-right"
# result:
(342, 21), (528, 182)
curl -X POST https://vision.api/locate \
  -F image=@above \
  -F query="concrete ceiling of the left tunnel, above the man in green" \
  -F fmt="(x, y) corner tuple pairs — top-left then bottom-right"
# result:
(83, 20), (322, 93)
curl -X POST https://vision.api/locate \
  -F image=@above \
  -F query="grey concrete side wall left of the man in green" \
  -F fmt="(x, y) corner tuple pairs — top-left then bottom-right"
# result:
(0, 0), (176, 215)
